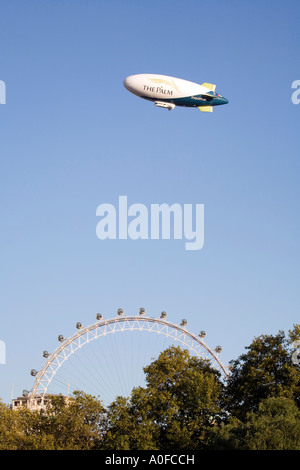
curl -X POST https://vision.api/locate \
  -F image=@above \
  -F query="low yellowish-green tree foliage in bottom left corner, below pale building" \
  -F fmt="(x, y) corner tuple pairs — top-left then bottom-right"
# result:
(0, 392), (105, 450)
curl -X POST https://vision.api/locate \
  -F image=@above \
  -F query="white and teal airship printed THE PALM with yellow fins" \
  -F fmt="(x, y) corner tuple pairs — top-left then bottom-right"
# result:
(123, 73), (228, 113)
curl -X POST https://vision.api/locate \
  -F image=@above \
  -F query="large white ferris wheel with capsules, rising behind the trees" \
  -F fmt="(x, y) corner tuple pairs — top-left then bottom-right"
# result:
(27, 308), (228, 403)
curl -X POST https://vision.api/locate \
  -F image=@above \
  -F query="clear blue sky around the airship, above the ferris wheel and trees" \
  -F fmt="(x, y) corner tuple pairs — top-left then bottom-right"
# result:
(0, 0), (300, 402)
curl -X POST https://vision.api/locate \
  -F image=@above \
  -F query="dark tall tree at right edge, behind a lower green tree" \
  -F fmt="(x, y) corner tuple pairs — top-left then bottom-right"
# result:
(224, 332), (300, 420)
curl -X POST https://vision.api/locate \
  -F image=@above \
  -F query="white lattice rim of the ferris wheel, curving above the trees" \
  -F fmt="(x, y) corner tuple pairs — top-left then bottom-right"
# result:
(28, 314), (229, 397)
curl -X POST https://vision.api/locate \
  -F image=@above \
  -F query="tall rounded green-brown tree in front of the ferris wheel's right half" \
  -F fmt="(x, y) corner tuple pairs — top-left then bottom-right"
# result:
(103, 347), (221, 450)
